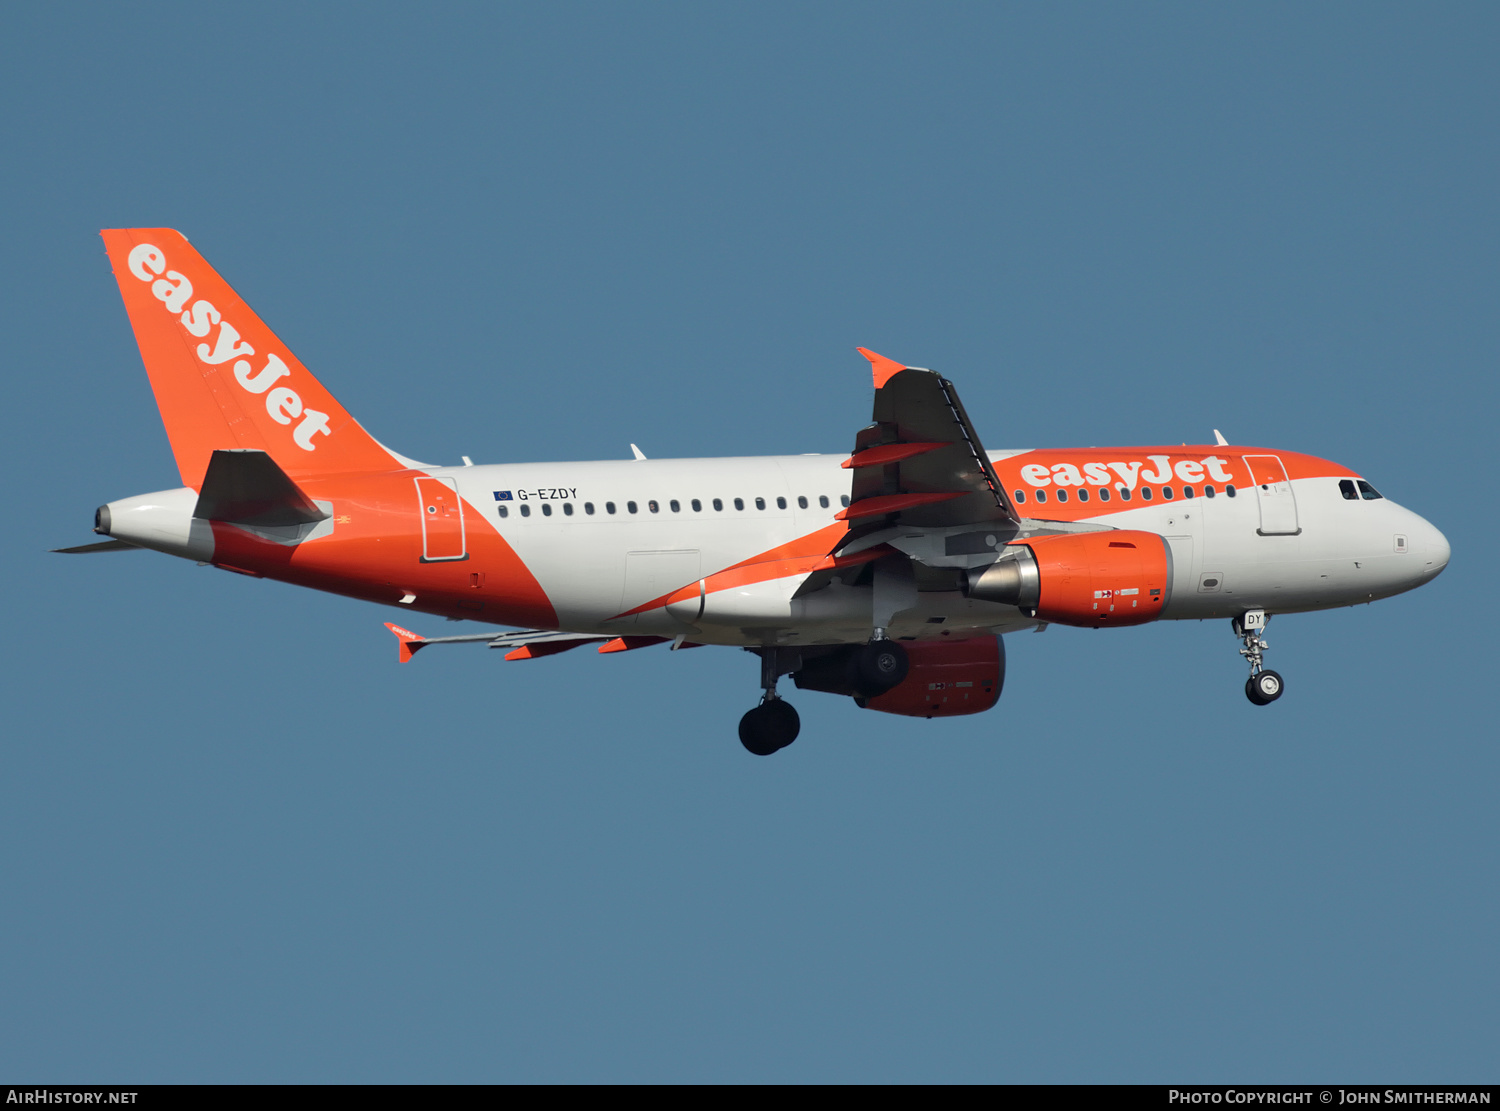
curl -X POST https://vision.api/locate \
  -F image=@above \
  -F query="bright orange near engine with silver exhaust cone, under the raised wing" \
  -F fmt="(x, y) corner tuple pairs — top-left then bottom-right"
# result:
(968, 529), (1172, 628)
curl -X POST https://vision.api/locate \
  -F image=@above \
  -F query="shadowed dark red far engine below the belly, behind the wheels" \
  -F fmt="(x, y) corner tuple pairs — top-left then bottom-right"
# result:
(792, 636), (1005, 718)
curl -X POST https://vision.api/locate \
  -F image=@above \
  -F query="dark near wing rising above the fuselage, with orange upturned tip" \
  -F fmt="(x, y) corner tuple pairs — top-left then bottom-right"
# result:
(837, 348), (1020, 531)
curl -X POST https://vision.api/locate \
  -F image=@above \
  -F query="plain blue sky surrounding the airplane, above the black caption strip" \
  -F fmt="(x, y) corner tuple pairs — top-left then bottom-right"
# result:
(0, 4), (1500, 1083)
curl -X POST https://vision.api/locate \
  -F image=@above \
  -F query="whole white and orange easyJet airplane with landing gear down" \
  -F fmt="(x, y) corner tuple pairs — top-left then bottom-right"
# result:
(57, 228), (1449, 756)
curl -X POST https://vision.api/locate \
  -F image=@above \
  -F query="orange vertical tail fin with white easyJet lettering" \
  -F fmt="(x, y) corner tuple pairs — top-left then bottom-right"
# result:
(101, 228), (407, 489)
